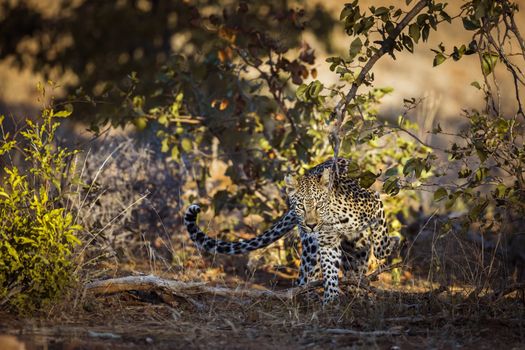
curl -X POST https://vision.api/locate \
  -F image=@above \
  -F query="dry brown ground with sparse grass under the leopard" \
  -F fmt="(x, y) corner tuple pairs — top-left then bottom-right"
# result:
(0, 266), (525, 349)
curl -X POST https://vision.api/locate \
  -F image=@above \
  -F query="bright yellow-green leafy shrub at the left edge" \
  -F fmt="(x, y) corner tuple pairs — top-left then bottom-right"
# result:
(0, 92), (81, 312)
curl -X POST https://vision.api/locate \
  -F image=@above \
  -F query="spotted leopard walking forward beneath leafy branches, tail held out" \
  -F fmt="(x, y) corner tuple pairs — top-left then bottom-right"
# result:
(184, 158), (399, 304)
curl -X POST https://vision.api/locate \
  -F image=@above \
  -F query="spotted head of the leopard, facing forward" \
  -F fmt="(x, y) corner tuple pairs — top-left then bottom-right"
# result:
(285, 169), (330, 232)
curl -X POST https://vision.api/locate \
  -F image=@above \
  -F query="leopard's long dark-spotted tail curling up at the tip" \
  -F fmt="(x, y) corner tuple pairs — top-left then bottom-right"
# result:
(184, 204), (296, 255)
